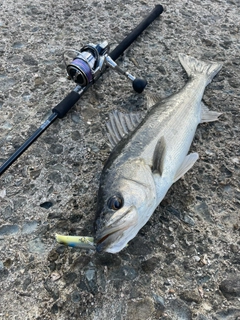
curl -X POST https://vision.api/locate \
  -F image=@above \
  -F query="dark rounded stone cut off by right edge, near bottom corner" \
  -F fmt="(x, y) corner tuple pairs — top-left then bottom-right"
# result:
(219, 275), (240, 300)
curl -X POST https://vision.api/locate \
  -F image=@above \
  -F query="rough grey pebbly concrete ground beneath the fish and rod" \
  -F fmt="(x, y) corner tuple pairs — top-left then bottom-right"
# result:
(0, 0), (240, 320)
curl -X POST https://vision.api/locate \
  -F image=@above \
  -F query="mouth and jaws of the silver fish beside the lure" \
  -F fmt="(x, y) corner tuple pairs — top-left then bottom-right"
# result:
(95, 206), (137, 253)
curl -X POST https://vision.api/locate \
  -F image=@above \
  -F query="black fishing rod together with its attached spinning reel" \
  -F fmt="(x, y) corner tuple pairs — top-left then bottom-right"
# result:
(0, 5), (163, 176)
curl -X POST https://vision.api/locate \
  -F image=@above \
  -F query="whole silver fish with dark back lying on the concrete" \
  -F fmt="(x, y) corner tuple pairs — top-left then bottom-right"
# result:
(95, 54), (222, 253)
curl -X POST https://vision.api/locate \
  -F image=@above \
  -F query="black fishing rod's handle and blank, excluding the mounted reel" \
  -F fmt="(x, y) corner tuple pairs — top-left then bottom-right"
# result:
(0, 4), (163, 176)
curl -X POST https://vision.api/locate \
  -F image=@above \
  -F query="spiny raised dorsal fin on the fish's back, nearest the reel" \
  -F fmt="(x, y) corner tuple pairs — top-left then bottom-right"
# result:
(106, 110), (143, 147)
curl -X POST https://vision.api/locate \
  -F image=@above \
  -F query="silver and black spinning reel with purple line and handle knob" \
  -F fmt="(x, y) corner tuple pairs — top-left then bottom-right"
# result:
(63, 41), (147, 93)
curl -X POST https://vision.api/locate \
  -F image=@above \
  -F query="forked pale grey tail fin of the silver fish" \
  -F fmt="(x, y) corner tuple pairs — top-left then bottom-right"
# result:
(178, 53), (222, 85)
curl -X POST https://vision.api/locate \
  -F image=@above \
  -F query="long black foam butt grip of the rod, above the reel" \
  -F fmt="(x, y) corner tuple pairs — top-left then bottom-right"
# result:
(109, 4), (163, 60)
